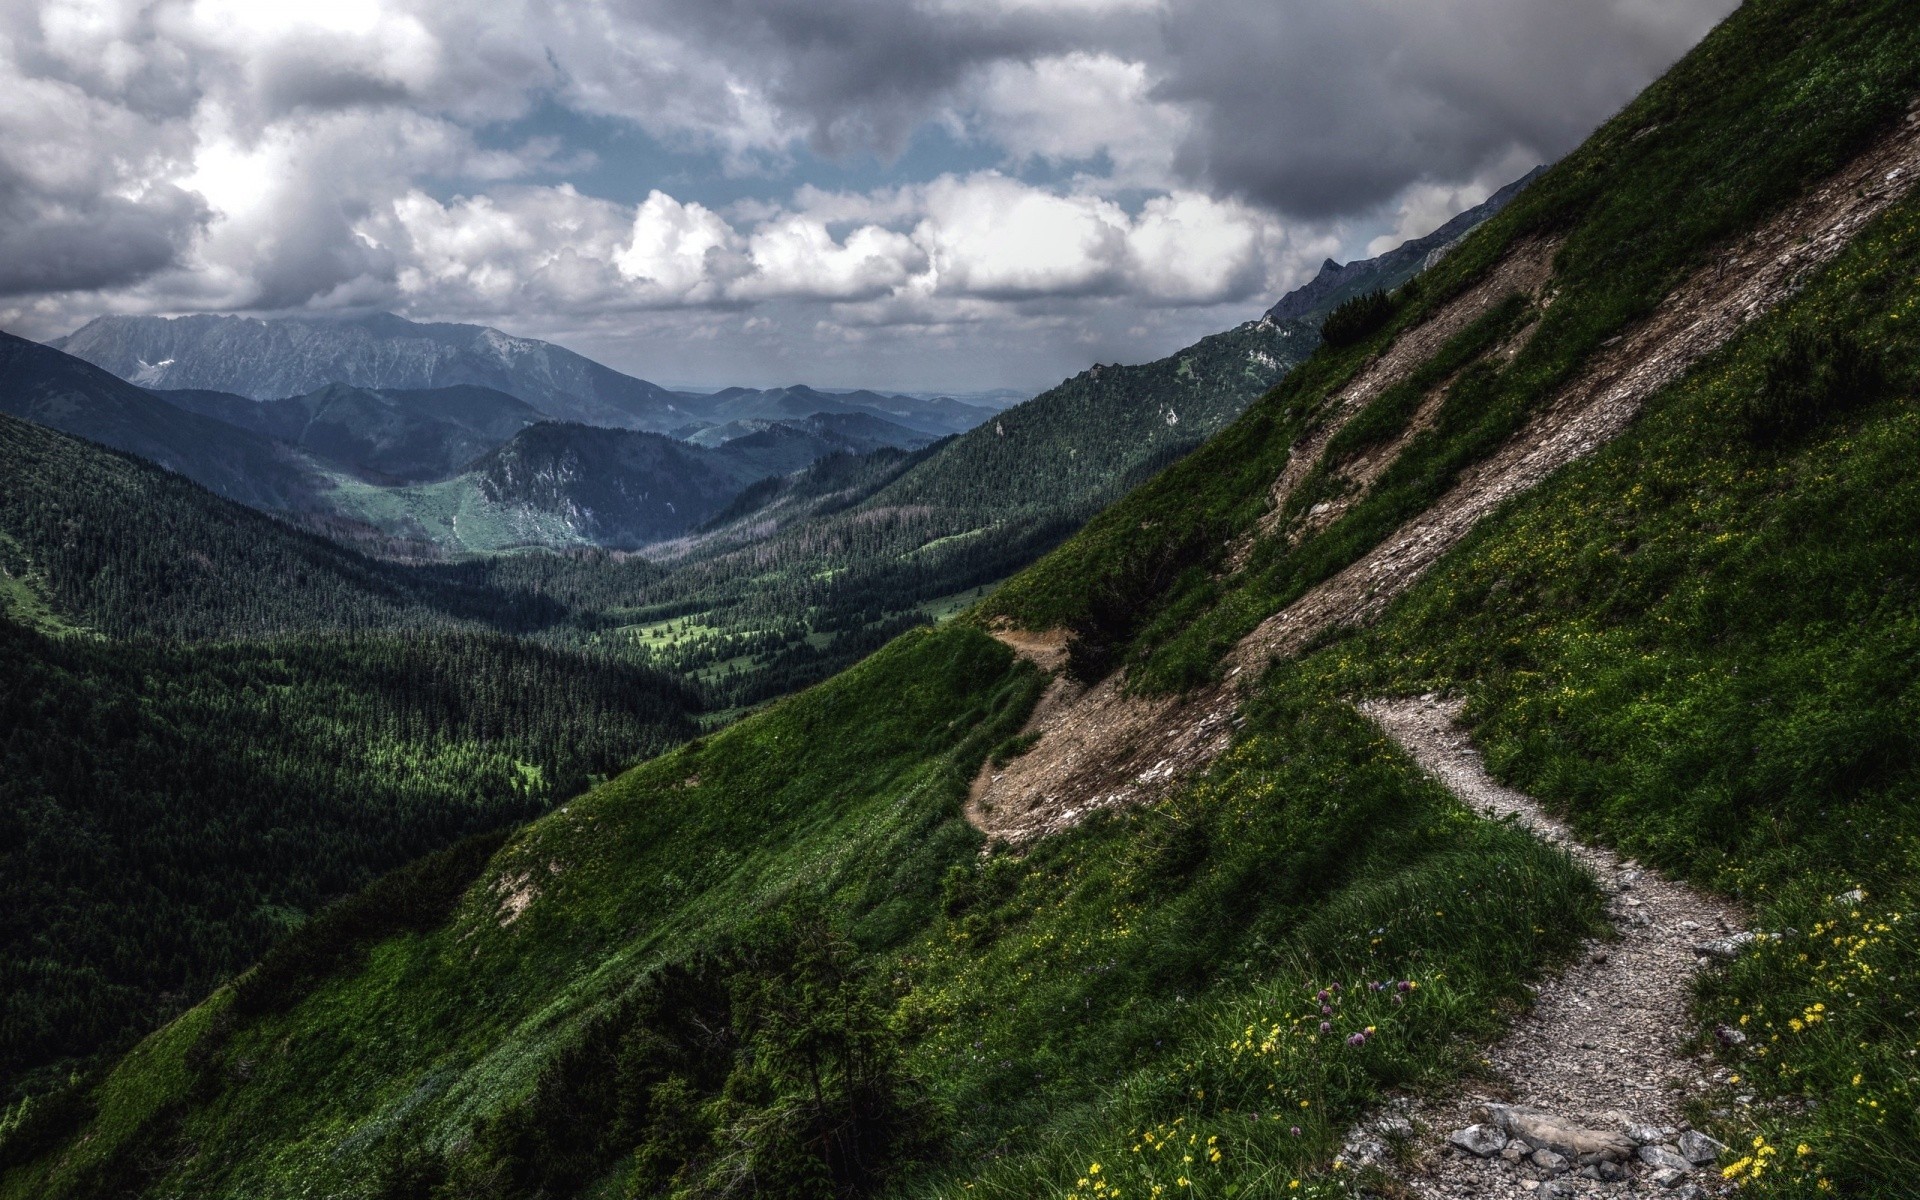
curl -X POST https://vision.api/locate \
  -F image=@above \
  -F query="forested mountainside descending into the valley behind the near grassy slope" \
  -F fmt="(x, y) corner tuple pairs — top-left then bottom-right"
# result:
(568, 175), (1528, 703)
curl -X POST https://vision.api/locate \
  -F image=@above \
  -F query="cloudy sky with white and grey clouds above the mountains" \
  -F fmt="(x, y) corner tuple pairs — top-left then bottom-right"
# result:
(0, 0), (1734, 390)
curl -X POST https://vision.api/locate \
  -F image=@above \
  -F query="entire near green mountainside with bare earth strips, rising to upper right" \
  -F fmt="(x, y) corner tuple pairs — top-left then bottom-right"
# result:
(15, 0), (1920, 1200)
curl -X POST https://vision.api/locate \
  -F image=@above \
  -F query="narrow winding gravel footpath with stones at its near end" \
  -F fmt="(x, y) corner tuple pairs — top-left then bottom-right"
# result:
(1350, 697), (1745, 1200)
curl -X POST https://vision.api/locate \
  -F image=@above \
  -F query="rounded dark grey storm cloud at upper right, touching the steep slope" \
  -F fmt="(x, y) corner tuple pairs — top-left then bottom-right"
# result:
(1160, 0), (1734, 217)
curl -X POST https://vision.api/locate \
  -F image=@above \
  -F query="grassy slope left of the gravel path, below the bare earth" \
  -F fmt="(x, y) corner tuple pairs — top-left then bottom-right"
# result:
(8, 630), (1594, 1196)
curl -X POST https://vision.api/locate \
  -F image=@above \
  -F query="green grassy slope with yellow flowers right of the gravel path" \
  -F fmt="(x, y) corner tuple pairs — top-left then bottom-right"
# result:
(1319, 192), (1920, 1196)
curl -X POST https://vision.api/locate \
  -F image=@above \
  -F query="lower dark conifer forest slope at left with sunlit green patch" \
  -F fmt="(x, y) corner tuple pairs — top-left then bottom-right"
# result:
(0, 618), (693, 1096)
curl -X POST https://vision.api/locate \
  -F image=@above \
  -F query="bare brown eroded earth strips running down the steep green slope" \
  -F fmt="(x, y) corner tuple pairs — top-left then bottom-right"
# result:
(968, 98), (1920, 841)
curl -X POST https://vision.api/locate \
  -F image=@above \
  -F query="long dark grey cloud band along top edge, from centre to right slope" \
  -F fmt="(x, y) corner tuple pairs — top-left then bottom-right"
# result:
(595, 0), (1734, 217)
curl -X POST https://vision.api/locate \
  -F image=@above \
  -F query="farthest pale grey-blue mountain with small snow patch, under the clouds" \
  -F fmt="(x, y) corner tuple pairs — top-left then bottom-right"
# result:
(50, 313), (687, 430)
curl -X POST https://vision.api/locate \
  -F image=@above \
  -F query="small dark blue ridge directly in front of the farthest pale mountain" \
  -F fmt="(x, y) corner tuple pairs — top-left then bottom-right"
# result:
(154, 384), (547, 484)
